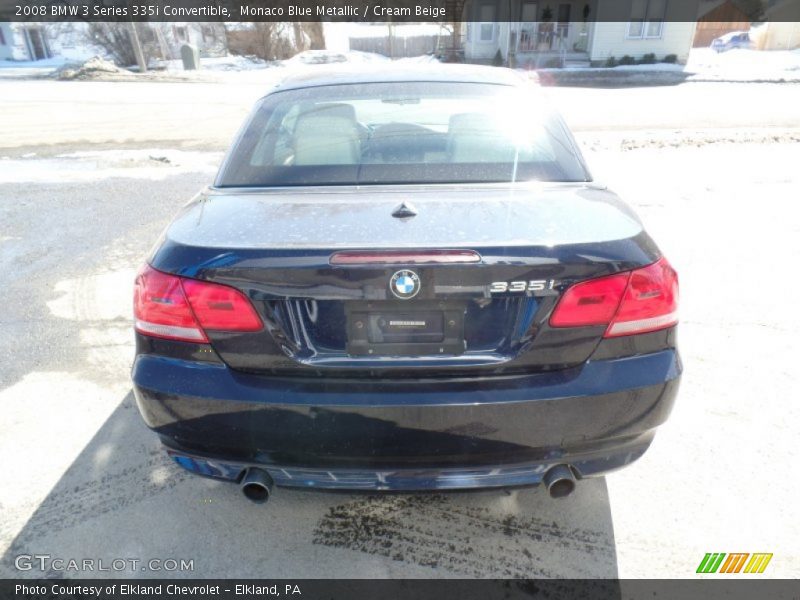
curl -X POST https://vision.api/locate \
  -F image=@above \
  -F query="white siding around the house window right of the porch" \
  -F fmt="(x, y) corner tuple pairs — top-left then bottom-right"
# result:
(589, 21), (697, 63)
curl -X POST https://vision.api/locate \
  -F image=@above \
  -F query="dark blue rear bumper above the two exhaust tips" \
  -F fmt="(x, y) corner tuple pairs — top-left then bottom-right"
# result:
(133, 350), (681, 490)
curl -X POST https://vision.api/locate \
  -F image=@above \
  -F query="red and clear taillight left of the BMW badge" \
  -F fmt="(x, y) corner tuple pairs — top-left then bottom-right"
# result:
(133, 266), (263, 343)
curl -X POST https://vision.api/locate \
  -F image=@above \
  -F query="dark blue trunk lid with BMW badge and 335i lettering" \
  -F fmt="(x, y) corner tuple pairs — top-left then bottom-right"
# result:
(152, 184), (658, 376)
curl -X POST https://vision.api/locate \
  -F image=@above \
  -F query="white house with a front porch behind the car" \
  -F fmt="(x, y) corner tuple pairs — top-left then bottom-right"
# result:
(462, 0), (698, 68)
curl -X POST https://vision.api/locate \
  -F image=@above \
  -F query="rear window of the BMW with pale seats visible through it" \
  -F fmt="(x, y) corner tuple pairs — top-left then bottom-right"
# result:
(217, 82), (588, 187)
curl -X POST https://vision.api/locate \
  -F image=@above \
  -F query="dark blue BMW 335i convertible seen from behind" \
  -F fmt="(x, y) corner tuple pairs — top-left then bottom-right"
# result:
(133, 66), (681, 502)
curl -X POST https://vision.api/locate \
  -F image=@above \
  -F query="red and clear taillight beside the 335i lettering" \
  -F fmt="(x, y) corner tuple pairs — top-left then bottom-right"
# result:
(550, 258), (678, 337)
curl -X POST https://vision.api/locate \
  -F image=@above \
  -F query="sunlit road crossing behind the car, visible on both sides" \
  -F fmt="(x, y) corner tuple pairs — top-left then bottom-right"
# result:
(0, 78), (800, 155)
